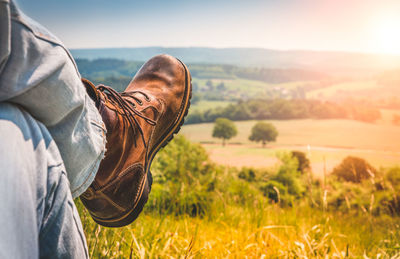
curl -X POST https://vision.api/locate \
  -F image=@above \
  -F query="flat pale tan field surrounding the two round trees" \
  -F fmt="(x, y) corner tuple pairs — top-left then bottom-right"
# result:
(182, 119), (400, 176)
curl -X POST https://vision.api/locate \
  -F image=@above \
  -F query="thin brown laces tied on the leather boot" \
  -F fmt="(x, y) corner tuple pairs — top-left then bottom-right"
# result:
(96, 85), (156, 147)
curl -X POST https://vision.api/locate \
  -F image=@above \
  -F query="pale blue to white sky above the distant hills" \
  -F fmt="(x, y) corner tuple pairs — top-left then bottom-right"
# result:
(17, 0), (400, 54)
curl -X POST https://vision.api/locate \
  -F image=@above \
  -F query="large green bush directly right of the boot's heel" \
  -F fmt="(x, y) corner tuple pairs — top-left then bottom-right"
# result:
(147, 136), (218, 216)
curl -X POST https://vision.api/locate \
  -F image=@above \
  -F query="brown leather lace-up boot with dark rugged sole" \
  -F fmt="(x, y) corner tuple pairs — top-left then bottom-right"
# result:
(80, 55), (192, 227)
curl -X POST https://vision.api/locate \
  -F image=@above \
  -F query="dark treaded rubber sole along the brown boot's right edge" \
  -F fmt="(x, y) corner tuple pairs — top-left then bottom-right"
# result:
(91, 59), (192, 227)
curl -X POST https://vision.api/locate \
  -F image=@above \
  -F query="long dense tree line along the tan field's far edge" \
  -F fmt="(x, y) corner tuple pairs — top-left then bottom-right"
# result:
(186, 99), (381, 124)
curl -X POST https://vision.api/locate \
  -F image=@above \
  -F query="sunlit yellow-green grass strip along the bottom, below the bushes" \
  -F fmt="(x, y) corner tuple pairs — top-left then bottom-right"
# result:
(78, 203), (400, 258)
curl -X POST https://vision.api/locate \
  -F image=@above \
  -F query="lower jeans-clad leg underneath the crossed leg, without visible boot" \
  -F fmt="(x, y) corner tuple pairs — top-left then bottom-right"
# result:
(0, 103), (88, 258)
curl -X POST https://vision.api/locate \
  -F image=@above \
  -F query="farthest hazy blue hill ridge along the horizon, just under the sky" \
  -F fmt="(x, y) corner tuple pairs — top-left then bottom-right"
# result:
(71, 47), (400, 76)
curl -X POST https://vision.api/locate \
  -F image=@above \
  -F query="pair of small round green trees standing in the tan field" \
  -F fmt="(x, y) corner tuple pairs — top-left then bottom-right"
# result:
(212, 118), (278, 147)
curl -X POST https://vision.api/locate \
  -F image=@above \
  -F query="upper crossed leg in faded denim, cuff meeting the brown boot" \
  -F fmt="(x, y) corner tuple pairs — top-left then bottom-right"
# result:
(0, 0), (105, 197)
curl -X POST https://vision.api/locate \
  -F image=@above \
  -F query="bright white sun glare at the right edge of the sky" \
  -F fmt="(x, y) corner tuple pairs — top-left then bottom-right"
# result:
(374, 17), (400, 54)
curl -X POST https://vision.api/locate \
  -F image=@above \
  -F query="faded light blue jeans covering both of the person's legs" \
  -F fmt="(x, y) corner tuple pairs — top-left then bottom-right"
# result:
(0, 0), (105, 258)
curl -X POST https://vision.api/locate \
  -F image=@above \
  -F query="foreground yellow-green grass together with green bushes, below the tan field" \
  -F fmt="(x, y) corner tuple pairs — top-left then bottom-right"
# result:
(76, 138), (400, 258)
